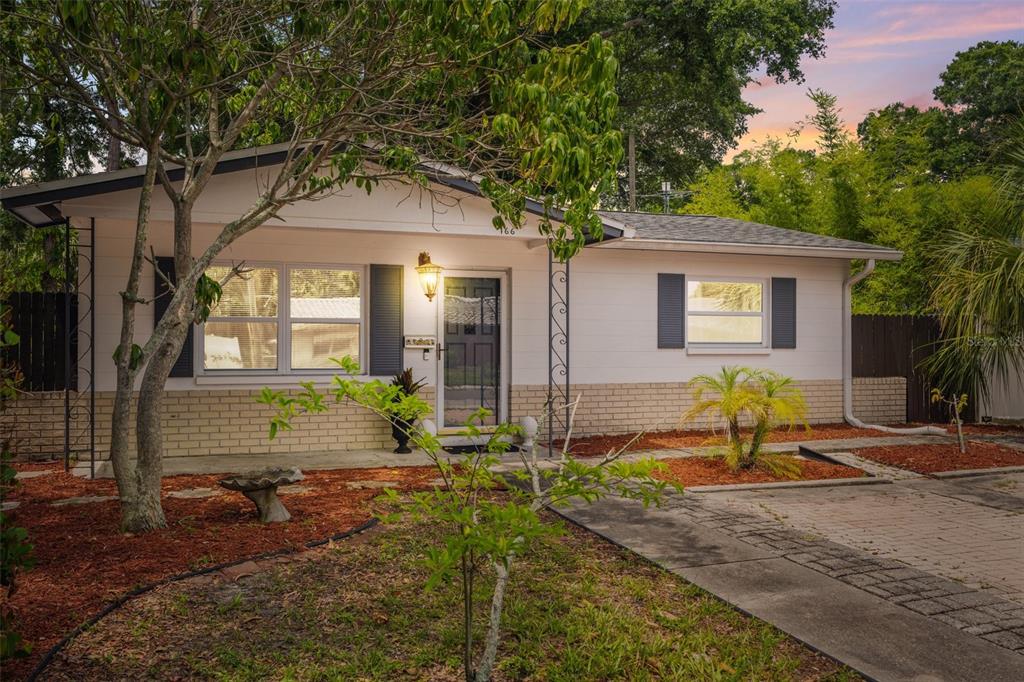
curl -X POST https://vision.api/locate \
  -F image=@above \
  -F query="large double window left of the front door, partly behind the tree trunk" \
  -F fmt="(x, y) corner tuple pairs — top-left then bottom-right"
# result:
(203, 265), (362, 372)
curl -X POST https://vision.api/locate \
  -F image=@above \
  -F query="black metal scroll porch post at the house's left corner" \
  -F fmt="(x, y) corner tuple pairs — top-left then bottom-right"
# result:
(63, 219), (96, 478)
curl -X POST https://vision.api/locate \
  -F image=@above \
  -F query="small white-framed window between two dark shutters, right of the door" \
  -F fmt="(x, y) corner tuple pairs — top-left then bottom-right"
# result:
(686, 280), (765, 345)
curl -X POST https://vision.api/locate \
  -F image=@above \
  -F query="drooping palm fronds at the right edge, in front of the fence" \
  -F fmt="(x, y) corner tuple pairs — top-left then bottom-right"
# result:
(926, 120), (1024, 396)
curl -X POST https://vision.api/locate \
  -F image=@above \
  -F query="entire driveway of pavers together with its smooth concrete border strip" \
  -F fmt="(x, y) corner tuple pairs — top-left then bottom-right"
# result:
(560, 466), (1024, 682)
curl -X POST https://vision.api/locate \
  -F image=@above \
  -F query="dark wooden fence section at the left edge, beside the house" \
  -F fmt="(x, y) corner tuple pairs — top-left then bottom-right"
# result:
(3, 292), (78, 391)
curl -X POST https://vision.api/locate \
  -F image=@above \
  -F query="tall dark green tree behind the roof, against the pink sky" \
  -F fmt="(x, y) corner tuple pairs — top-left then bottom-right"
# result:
(559, 0), (836, 205)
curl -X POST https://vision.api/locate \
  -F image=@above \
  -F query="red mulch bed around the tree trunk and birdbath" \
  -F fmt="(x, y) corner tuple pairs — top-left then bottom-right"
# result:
(4, 458), (437, 679)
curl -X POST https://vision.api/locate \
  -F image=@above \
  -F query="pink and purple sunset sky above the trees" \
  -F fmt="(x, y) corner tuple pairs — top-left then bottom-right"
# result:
(726, 0), (1024, 160)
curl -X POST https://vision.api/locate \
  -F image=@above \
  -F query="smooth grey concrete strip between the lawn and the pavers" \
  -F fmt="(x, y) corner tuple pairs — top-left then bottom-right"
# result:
(562, 498), (1024, 682)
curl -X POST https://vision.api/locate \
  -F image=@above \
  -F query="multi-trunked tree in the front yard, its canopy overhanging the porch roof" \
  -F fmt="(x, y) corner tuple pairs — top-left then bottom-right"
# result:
(2, 0), (621, 531)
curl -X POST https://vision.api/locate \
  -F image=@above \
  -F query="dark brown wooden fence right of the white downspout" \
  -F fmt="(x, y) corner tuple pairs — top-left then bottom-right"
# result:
(853, 315), (974, 422)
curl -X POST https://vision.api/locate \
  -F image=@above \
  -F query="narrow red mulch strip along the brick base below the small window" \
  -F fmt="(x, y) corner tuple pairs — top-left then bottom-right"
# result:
(555, 424), (942, 457)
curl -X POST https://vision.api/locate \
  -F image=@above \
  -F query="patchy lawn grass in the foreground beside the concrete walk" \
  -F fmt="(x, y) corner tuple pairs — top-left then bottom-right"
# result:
(43, 512), (859, 680)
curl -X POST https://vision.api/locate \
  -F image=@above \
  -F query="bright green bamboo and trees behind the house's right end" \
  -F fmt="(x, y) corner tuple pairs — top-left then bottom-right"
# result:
(681, 36), (1024, 313)
